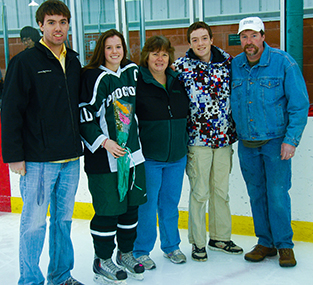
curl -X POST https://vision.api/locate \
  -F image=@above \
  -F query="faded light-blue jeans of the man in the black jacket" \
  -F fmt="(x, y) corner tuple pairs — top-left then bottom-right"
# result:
(18, 160), (79, 285)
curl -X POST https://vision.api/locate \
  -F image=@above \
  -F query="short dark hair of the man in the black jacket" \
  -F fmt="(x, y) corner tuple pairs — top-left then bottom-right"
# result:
(36, 0), (71, 24)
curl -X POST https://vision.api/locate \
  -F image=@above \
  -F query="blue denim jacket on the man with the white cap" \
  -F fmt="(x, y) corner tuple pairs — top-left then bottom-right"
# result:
(231, 42), (309, 146)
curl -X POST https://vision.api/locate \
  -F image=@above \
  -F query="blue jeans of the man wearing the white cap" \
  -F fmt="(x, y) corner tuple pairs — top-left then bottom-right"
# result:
(238, 138), (293, 249)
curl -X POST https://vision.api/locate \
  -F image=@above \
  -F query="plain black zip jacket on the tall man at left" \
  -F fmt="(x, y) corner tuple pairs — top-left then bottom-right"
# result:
(1, 43), (82, 163)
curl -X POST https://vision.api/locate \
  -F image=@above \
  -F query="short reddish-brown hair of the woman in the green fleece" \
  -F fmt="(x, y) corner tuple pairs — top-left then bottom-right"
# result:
(140, 36), (175, 67)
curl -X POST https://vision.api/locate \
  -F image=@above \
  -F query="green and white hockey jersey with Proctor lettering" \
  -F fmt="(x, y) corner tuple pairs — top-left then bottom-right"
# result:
(79, 61), (144, 174)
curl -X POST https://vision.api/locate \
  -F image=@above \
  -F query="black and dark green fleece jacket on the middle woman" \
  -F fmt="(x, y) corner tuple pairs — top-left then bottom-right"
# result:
(136, 67), (189, 162)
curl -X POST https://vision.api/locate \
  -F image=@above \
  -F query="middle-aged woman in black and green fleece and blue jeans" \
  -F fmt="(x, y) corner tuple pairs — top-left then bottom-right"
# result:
(134, 36), (189, 269)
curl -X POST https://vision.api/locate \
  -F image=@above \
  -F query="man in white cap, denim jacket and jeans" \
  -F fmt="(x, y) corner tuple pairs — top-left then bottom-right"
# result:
(231, 17), (309, 267)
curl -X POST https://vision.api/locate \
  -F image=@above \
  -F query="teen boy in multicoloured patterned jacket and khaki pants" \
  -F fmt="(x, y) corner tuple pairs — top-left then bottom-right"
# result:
(174, 22), (243, 261)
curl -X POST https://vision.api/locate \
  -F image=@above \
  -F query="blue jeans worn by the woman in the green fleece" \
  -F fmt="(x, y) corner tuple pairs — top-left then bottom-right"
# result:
(134, 156), (187, 255)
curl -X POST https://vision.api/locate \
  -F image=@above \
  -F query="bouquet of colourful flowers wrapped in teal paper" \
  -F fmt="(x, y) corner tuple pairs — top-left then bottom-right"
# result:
(113, 99), (133, 202)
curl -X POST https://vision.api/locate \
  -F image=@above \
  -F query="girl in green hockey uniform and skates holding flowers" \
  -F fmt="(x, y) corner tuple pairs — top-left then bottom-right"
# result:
(80, 29), (146, 284)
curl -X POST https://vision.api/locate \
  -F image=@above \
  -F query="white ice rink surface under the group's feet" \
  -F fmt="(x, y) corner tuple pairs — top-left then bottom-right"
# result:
(0, 212), (313, 285)
